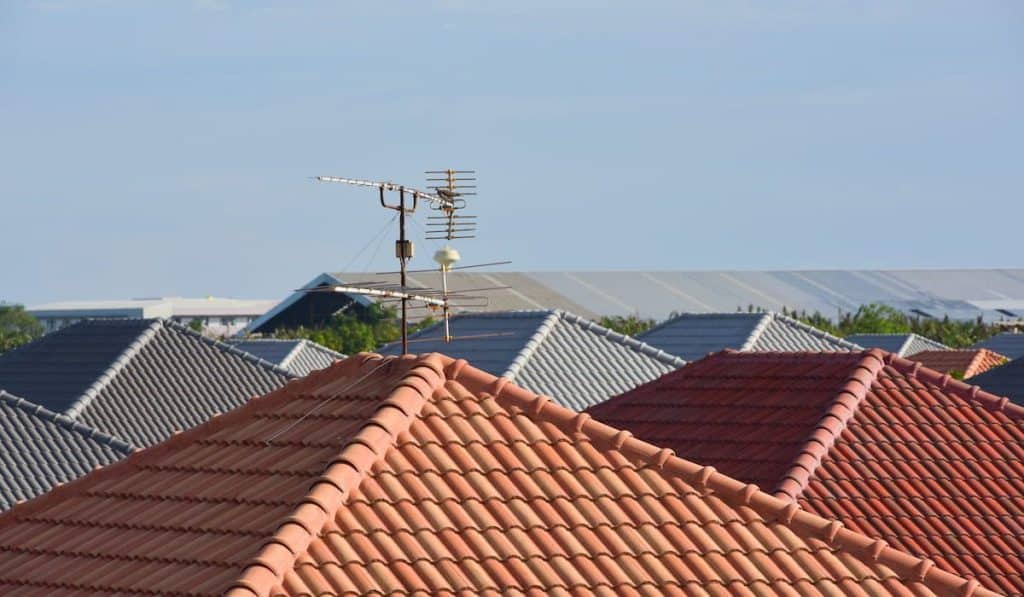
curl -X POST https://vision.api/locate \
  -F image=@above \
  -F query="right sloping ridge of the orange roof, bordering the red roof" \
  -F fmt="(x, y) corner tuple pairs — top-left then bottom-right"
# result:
(442, 356), (995, 596)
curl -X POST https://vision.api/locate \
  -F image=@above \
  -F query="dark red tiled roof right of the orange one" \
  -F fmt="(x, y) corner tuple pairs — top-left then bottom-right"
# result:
(588, 349), (1024, 594)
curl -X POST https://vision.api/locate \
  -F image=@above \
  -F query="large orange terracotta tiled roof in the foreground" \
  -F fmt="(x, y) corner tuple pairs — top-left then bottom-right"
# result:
(0, 354), (990, 597)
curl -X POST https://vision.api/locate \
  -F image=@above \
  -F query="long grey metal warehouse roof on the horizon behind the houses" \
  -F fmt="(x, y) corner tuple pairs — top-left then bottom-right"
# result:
(249, 268), (1024, 333)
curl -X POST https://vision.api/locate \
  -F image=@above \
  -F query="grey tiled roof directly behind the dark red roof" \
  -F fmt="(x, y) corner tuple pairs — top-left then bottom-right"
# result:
(637, 312), (860, 360)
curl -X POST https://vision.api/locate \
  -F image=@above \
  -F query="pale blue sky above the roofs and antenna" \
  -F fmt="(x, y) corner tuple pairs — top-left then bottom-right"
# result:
(0, 0), (1024, 305)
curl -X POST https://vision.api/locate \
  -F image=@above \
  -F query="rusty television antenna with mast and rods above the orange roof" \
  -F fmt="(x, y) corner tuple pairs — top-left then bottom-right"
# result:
(305, 169), (508, 353)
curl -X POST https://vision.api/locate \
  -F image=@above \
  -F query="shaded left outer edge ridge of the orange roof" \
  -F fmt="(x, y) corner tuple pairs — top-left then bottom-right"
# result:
(0, 356), (348, 527)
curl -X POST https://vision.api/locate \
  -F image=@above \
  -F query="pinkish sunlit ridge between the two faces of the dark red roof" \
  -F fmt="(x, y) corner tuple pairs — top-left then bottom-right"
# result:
(772, 348), (885, 503)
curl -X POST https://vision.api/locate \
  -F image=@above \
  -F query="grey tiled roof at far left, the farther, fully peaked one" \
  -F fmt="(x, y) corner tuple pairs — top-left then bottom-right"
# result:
(0, 319), (292, 445)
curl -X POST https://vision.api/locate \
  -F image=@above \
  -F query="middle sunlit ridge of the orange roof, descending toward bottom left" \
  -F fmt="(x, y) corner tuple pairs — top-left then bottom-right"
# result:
(225, 354), (446, 596)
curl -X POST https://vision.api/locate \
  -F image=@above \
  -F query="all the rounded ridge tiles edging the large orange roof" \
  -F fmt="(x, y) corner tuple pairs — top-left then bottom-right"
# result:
(0, 353), (984, 595)
